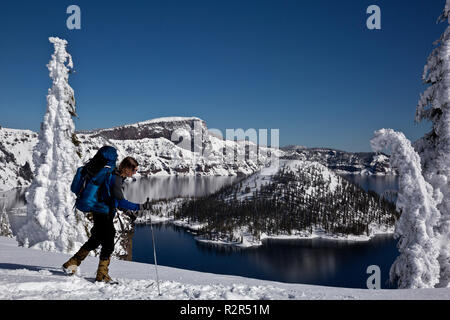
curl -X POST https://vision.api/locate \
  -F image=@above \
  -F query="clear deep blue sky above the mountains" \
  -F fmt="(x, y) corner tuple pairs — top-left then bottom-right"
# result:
(0, 0), (446, 151)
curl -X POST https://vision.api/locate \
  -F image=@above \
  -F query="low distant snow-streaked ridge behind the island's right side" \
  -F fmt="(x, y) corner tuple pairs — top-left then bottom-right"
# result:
(281, 145), (395, 175)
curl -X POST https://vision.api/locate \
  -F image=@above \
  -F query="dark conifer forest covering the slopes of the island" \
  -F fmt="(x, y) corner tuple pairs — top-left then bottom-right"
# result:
(173, 167), (398, 242)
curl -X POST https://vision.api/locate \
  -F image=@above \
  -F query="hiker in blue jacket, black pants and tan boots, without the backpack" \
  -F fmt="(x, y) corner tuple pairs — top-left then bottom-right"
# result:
(63, 152), (150, 283)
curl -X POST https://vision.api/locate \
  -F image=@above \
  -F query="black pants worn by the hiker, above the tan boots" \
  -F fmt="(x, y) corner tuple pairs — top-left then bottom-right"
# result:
(82, 212), (116, 260)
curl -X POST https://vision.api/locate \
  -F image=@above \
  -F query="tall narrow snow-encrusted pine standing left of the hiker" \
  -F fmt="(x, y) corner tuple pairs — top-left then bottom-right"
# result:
(17, 37), (87, 252)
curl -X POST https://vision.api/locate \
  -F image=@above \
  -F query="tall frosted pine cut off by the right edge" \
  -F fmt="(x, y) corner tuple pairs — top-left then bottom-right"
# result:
(415, 0), (450, 286)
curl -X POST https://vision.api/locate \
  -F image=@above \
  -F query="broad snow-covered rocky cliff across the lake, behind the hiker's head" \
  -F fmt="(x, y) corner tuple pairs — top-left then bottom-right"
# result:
(77, 117), (276, 176)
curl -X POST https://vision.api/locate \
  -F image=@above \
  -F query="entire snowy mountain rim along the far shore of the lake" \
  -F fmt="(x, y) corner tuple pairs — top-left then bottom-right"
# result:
(0, 117), (392, 191)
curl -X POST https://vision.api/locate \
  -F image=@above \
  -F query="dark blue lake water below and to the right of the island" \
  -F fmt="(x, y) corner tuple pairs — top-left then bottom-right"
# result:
(132, 176), (398, 288)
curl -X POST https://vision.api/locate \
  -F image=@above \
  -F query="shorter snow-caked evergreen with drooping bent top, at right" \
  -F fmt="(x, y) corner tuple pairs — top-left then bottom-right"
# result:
(371, 129), (440, 288)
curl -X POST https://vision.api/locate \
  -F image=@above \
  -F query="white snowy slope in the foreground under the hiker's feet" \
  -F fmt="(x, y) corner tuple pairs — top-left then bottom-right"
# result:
(0, 237), (450, 300)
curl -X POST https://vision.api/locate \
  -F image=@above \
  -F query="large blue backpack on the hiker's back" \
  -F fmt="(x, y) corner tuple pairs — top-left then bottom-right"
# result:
(70, 146), (117, 213)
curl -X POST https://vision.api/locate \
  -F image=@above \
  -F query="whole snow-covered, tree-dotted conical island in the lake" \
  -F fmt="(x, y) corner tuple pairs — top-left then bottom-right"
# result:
(136, 160), (398, 247)
